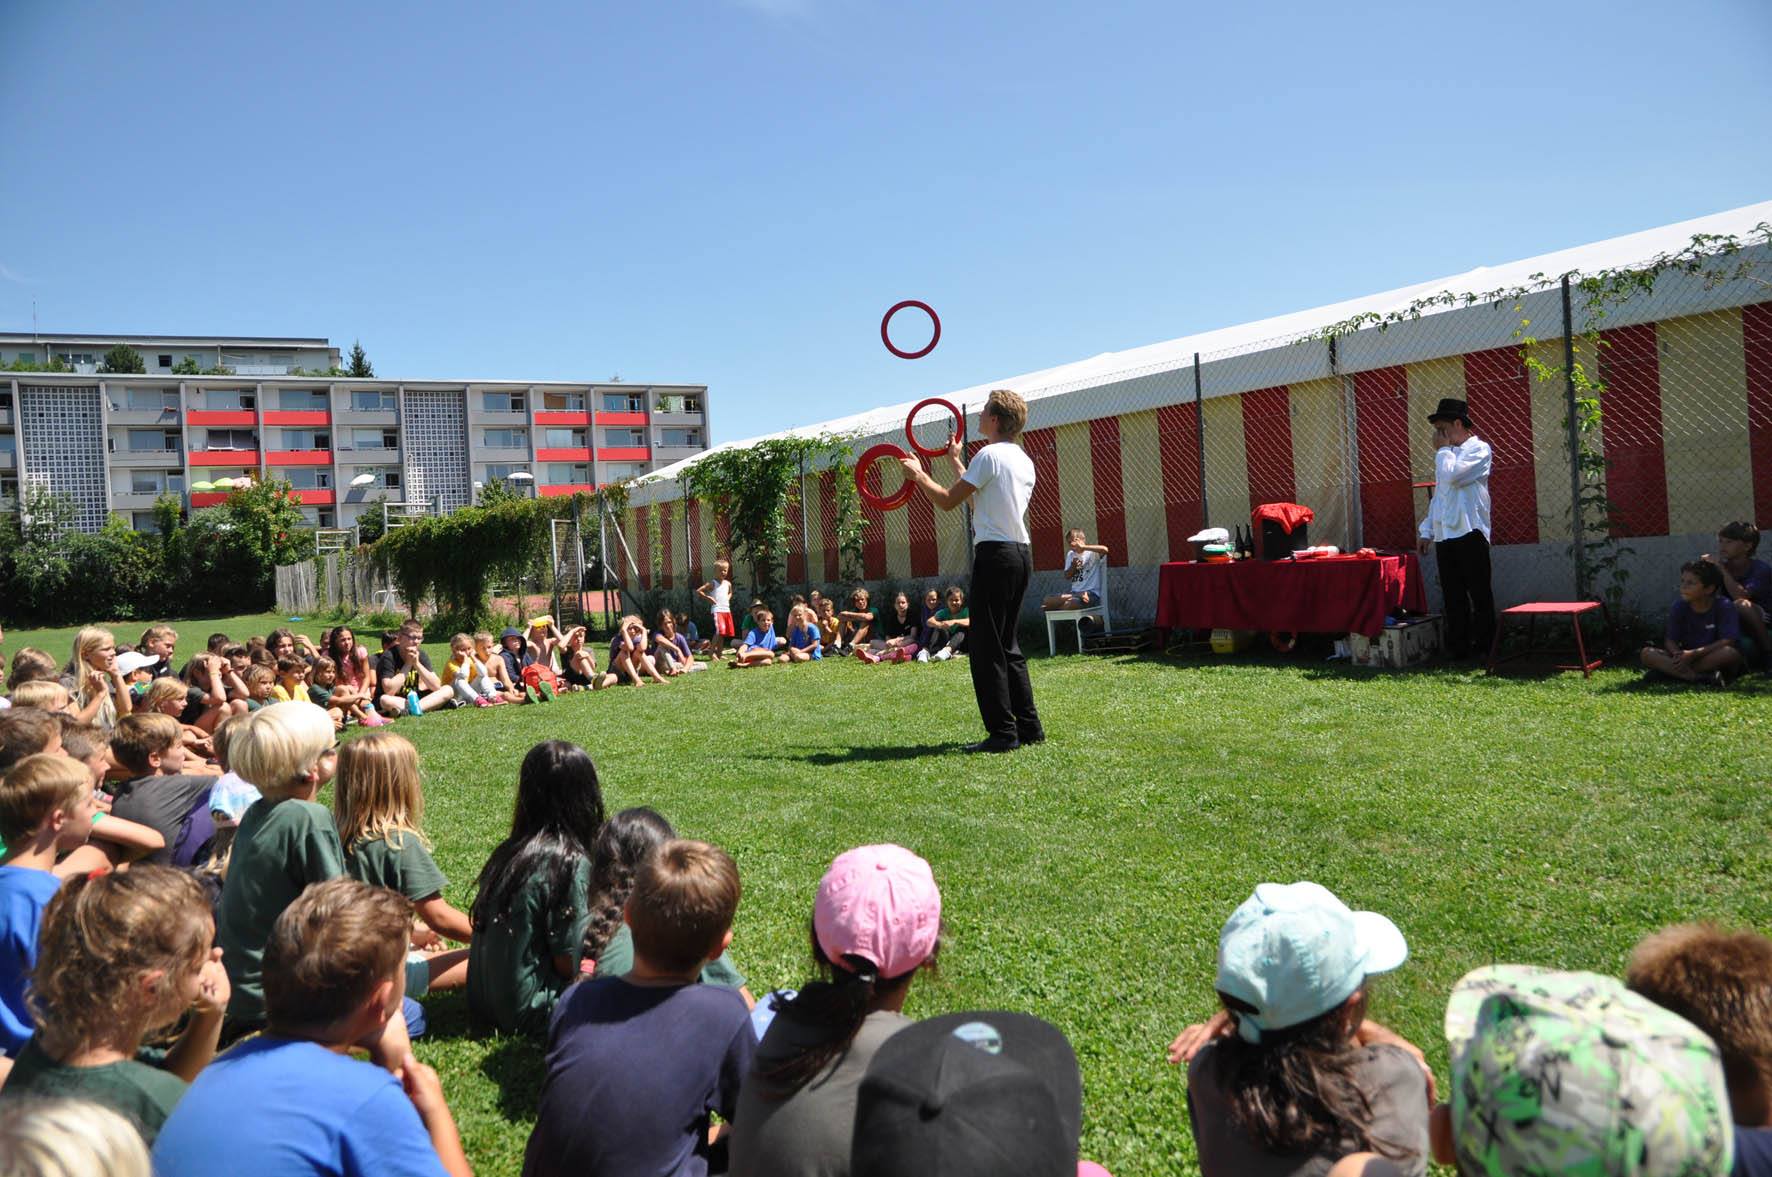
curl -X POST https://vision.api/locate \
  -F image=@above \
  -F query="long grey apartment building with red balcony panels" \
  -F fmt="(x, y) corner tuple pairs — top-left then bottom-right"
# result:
(0, 372), (709, 530)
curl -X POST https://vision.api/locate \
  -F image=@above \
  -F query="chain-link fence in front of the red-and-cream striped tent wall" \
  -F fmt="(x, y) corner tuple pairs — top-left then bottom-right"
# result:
(622, 235), (1772, 645)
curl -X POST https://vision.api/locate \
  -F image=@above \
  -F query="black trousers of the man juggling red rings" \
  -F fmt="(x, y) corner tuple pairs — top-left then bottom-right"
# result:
(966, 541), (1044, 739)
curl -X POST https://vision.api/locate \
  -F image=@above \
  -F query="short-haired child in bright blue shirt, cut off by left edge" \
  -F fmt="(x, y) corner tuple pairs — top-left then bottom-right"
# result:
(0, 758), (97, 1063)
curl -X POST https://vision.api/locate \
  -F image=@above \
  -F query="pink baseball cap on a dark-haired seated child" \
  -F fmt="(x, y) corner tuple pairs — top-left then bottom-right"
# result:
(812, 844), (941, 977)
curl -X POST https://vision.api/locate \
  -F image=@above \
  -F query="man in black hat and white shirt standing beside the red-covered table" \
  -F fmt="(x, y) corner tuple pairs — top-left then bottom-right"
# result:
(1419, 399), (1496, 658)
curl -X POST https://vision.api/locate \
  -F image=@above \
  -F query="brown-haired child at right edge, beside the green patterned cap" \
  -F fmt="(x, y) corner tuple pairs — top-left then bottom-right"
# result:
(1625, 924), (1772, 1177)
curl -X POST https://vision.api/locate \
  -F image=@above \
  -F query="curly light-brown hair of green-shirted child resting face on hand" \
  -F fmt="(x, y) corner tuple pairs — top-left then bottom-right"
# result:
(25, 863), (214, 1062)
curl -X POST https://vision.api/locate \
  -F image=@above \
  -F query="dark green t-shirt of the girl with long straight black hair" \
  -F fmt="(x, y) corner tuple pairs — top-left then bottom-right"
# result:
(468, 860), (590, 1037)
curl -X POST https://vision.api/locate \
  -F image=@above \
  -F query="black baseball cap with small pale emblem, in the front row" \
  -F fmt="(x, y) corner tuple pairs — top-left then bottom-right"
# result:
(849, 1010), (1083, 1177)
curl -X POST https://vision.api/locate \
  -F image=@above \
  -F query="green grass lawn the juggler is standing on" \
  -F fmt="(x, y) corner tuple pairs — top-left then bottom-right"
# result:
(5, 619), (1772, 1177)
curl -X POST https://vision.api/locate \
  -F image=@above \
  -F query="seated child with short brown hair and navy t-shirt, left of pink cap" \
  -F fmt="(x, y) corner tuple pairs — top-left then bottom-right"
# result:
(523, 840), (757, 1177)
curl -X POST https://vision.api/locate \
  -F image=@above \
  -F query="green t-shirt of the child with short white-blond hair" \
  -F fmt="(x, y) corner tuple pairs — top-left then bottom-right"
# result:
(216, 798), (344, 1021)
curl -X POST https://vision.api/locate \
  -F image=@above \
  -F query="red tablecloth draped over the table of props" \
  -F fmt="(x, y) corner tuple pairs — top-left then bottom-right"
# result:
(1157, 555), (1428, 638)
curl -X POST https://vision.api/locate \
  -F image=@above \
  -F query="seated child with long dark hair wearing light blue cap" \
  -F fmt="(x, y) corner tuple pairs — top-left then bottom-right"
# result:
(1170, 883), (1432, 1177)
